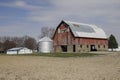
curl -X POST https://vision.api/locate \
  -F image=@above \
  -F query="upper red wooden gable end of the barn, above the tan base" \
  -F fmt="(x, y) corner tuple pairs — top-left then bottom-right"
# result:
(54, 24), (75, 45)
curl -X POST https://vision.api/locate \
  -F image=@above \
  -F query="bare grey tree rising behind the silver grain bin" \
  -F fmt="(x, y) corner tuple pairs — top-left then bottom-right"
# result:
(39, 27), (55, 38)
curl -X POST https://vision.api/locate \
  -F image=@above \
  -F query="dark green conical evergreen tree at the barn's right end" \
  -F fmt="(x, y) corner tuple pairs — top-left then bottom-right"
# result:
(108, 34), (118, 51)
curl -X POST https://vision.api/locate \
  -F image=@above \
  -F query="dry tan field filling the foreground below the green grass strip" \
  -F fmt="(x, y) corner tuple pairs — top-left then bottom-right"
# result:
(0, 53), (120, 80)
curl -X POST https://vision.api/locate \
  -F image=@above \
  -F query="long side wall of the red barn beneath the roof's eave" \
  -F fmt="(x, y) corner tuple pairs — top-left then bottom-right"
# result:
(76, 38), (108, 52)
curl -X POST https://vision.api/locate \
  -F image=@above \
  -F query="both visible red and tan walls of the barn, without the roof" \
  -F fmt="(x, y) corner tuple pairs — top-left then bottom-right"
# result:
(54, 24), (108, 52)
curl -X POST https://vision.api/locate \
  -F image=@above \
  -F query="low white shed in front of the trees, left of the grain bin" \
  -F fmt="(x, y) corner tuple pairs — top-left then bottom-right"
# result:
(7, 47), (32, 54)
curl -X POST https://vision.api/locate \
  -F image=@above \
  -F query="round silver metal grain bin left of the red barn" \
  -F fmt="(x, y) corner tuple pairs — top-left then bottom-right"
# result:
(39, 37), (53, 53)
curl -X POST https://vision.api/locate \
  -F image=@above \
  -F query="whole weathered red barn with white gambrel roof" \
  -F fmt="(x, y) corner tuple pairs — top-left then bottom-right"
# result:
(53, 21), (108, 52)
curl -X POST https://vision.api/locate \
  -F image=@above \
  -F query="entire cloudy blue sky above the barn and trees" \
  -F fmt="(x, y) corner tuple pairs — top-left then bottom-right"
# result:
(0, 0), (120, 43)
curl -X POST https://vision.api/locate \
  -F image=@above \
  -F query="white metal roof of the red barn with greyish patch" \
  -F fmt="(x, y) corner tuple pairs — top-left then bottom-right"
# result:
(64, 21), (107, 39)
